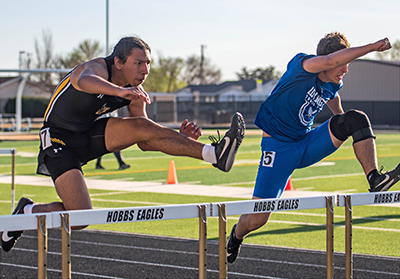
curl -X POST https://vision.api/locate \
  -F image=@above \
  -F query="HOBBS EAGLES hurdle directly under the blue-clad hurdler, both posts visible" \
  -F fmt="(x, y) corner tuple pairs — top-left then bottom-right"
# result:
(211, 196), (334, 279)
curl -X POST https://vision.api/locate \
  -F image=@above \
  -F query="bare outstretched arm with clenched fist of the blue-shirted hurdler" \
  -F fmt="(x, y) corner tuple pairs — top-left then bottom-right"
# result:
(303, 38), (392, 73)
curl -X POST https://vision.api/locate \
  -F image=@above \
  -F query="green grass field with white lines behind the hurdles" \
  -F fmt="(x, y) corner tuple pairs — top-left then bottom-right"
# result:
(0, 133), (400, 256)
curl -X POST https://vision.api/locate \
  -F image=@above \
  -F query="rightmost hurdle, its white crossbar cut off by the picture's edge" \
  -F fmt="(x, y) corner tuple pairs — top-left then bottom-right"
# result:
(337, 191), (400, 279)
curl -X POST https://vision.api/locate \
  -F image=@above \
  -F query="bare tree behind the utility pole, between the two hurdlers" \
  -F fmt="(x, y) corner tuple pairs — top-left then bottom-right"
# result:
(184, 55), (222, 85)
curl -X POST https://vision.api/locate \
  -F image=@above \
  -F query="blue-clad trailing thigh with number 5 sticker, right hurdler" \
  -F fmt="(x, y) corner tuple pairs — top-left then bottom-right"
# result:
(253, 137), (302, 199)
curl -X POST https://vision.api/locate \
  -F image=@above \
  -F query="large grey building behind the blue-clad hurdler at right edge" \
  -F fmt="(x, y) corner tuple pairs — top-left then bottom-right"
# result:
(316, 59), (400, 129)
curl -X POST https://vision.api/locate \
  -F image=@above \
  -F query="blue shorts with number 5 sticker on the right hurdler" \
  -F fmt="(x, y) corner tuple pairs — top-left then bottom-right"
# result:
(253, 120), (337, 199)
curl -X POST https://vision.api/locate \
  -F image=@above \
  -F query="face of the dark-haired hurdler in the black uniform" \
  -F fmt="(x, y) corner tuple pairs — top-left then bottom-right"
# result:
(122, 48), (151, 86)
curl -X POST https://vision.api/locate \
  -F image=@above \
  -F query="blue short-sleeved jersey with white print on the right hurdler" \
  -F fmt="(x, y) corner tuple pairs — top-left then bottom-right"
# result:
(254, 53), (343, 141)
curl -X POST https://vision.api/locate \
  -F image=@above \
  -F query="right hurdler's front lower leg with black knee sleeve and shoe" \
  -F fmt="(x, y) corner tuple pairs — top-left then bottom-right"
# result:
(329, 110), (400, 192)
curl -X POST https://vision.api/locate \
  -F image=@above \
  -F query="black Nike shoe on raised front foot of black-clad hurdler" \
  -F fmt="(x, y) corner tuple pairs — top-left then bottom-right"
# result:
(209, 112), (245, 172)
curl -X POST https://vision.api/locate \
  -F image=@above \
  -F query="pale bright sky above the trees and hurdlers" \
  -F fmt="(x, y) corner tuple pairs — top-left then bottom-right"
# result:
(0, 0), (400, 81)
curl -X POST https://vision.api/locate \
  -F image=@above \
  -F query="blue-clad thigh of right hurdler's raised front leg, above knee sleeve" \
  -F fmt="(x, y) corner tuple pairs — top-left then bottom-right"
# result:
(298, 120), (337, 168)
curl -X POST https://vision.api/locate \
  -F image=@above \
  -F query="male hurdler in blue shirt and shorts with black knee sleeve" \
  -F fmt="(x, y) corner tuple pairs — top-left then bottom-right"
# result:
(227, 32), (400, 263)
